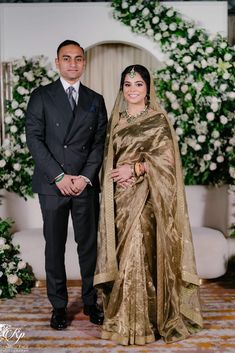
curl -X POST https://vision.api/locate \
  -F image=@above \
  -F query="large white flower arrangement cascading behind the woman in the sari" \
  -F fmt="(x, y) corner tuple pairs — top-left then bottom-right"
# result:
(112, 0), (235, 185)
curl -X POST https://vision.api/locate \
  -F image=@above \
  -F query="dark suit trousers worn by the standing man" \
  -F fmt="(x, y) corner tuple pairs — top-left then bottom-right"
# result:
(39, 185), (99, 308)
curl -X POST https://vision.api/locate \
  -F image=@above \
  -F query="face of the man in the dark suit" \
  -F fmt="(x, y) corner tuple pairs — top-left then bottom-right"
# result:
(55, 44), (86, 84)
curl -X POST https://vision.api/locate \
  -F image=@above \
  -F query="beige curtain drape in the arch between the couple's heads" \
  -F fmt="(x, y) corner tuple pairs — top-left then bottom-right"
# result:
(82, 43), (161, 115)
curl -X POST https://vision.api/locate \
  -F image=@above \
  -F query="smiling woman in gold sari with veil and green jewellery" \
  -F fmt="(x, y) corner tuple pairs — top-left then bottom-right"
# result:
(95, 65), (202, 345)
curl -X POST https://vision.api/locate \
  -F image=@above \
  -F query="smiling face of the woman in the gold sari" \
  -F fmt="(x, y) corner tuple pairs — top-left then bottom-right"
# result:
(123, 72), (147, 106)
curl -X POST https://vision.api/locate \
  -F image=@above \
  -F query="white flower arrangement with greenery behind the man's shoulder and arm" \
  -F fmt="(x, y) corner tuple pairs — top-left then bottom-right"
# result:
(0, 55), (57, 198)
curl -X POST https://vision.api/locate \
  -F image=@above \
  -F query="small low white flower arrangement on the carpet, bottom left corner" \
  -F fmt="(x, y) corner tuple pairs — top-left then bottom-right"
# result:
(0, 219), (35, 298)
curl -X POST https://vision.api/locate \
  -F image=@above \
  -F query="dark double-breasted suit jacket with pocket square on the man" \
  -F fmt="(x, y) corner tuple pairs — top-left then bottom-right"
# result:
(26, 79), (107, 195)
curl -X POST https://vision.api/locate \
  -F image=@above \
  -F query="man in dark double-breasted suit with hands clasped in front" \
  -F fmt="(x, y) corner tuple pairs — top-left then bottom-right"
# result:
(26, 40), (107, 330)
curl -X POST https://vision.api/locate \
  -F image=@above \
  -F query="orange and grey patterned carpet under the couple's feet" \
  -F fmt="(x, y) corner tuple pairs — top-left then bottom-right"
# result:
(0, 266), (235, 353)
